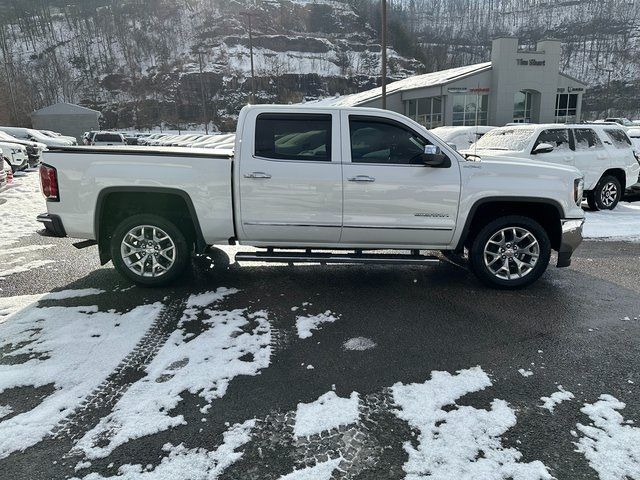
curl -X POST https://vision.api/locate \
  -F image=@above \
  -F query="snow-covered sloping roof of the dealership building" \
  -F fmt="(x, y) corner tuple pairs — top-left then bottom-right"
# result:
(318, 62), (491, 107)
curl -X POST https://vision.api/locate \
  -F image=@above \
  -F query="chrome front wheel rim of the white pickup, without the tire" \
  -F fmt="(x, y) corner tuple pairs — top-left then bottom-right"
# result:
(483, 227), (540, 280)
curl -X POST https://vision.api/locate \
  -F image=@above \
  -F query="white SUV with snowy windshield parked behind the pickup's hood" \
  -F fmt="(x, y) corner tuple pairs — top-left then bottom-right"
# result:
(463, 124), (640, 210)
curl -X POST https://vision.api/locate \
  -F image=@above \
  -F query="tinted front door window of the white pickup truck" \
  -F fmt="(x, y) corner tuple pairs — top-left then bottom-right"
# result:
(349, 116), (429, 165)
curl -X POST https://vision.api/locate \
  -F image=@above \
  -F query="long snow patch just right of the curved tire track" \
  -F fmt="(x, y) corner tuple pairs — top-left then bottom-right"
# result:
(77, 288), (271, 459)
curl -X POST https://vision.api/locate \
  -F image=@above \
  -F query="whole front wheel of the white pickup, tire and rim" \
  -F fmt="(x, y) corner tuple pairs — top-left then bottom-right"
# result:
(469, 215), (551, 290)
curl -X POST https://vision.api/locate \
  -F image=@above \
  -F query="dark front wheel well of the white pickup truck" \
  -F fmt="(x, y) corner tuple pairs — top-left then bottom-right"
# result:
(463, 201), (562, 250)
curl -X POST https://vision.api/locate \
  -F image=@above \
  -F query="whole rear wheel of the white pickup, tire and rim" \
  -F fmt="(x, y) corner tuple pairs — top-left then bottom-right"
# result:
(111, 214), (191, 287)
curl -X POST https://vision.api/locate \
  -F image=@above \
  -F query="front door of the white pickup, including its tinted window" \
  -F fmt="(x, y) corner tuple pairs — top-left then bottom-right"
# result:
(341, 112), (460, 247)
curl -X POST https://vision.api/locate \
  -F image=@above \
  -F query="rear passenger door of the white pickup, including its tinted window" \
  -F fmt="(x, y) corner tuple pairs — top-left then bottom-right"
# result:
(236, 108), (342, 246)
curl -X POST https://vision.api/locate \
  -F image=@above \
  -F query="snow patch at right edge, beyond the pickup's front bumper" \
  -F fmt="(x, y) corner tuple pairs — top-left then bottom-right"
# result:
(583, 202), (640, 241)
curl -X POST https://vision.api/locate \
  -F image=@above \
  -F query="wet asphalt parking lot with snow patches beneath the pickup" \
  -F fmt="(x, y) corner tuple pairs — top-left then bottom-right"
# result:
(0, 171), (640, 480)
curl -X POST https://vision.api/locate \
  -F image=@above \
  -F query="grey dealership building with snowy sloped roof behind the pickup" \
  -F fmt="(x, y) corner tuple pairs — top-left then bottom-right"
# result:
(321, 37), (587, 128)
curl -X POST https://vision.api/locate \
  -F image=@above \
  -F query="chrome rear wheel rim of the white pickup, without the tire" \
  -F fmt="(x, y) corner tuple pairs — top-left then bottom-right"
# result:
(120, 225), (176, 277)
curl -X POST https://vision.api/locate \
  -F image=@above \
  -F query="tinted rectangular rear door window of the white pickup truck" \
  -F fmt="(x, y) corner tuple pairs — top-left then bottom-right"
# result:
(255, 113), (331, 162)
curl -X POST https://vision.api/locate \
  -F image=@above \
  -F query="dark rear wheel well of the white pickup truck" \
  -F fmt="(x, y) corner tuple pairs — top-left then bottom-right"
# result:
(95, 190), (202, 265)
